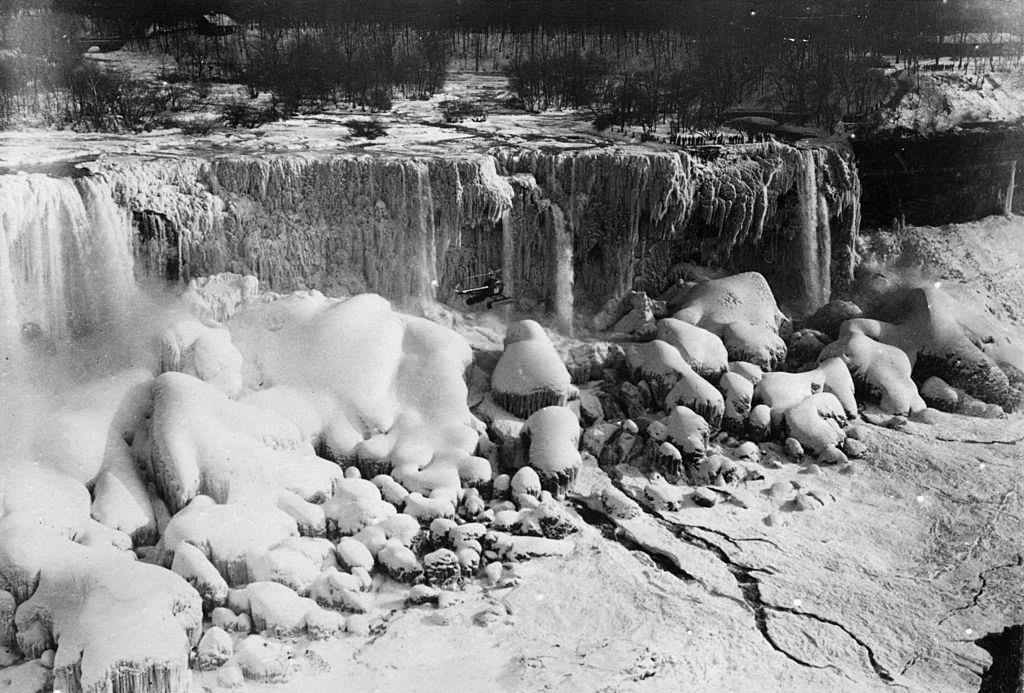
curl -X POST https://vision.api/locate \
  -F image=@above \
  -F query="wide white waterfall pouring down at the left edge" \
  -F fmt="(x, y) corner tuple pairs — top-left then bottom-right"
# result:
(0, 174), (135, 359)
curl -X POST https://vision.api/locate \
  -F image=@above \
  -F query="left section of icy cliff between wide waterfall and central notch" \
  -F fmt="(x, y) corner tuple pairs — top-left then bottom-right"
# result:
(103, 156), (512, 298)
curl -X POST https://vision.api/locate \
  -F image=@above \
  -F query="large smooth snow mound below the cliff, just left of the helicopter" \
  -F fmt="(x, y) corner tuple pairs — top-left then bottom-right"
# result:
(228, 292), (480, 470)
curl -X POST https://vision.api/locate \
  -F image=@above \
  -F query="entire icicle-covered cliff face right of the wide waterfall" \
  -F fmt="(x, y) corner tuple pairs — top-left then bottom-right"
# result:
(83, 143), (860, 324)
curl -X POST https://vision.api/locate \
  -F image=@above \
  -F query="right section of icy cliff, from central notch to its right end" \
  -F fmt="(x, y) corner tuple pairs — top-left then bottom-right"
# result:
(495, 143), (860, 319)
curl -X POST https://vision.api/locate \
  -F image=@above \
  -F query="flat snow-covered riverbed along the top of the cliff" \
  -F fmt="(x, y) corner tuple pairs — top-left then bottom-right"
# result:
(0, 60), (802, 170)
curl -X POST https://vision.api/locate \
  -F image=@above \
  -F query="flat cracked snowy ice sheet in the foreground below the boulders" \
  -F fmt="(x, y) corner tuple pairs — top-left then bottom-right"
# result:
(182, 403), (1024, 693)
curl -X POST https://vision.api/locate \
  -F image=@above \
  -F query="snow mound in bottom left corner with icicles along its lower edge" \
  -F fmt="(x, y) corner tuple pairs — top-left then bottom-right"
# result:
(0, 517), (202, 691)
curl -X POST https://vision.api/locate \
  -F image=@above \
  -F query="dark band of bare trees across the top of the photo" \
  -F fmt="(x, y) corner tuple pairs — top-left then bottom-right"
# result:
(0, 0), (1024, 129)
